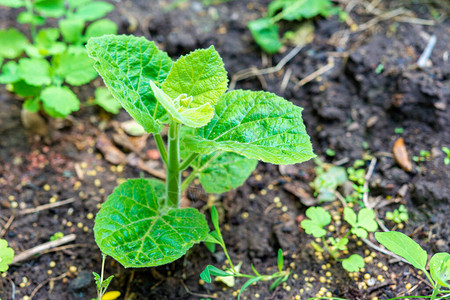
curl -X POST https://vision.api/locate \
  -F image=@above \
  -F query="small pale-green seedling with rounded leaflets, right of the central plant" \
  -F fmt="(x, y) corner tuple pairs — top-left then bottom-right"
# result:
(300, 206), (378, 272)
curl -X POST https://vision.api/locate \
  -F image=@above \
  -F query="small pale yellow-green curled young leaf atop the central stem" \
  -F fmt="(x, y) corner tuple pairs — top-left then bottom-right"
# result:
(150, 81), (214, 128)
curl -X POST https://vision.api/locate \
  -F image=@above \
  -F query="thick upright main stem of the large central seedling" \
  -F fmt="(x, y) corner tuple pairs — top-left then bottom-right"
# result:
(166, 120), (181, 207)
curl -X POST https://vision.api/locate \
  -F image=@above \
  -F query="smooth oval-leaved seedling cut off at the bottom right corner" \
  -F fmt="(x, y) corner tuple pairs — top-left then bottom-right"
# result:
(375, 231), (450, 300)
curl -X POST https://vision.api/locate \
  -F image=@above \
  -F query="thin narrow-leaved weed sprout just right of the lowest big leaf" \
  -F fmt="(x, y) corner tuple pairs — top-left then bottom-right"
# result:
(200, 206), (291, 299)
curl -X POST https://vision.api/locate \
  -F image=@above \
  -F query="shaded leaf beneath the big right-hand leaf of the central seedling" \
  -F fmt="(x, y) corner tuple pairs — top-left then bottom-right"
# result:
(191, 152), (258, 194)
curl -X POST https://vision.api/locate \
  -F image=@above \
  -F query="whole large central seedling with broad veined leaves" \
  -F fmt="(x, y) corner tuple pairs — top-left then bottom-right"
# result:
(87, 35), (315, 278)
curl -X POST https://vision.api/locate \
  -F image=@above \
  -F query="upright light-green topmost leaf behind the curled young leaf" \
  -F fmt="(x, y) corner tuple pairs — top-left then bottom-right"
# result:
(162, 46), (228, 107)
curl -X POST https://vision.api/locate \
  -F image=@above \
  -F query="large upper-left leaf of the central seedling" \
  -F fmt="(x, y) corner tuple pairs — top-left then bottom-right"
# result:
(86, 35), (172, 133)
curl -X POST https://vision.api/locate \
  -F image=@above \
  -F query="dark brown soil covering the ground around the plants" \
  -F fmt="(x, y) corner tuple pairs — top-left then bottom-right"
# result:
(0, 0), (450, 300)
